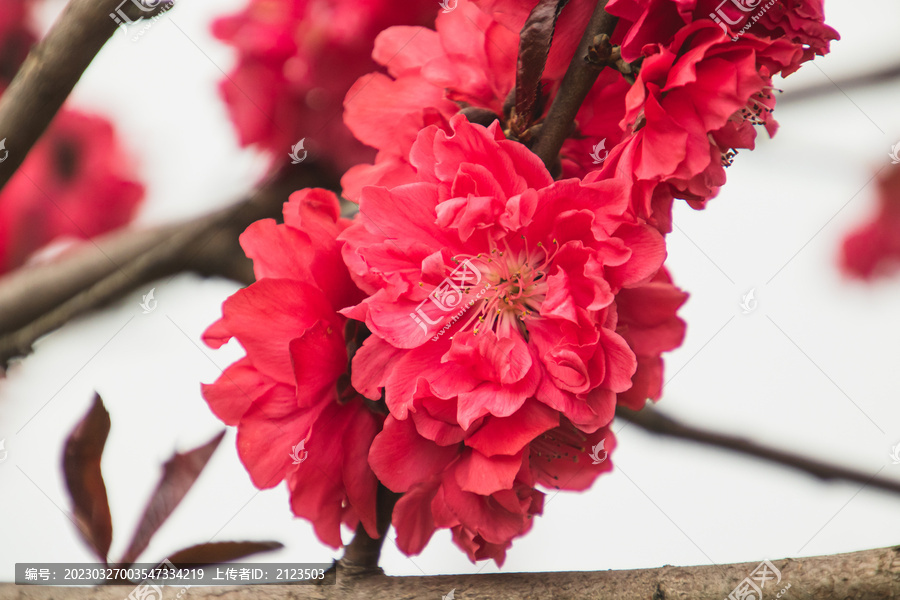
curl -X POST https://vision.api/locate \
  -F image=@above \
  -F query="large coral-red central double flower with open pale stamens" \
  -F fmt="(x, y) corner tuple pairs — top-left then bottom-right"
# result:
(342, 115), (665, 431)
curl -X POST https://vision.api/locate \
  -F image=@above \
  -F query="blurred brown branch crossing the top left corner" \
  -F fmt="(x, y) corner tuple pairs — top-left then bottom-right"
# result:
(0, 0), (168, 190)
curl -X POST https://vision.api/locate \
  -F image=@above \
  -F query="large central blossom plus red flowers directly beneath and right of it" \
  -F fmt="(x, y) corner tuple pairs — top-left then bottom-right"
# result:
(341, 115), (685, 562)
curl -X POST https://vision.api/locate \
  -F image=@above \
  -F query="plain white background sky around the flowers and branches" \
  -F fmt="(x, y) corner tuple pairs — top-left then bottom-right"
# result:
(0, 0), (900, 581)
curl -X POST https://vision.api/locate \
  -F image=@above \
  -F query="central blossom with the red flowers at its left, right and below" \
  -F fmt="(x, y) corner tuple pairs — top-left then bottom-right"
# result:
(204, 115), (686, 562)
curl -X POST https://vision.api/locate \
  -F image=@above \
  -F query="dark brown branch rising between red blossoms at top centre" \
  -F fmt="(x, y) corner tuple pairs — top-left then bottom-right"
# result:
(532, 0), (617, 172)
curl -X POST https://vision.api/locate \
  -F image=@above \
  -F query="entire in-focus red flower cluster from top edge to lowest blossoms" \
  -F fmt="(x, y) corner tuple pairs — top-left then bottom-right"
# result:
(204, 0), (836, 564)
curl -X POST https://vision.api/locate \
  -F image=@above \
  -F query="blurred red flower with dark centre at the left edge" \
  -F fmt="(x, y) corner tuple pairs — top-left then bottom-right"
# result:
(0, 109), (144, 273)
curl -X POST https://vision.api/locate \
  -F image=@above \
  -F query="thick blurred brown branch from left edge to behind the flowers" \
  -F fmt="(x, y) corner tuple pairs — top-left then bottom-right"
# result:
(0, 165), (336, 368)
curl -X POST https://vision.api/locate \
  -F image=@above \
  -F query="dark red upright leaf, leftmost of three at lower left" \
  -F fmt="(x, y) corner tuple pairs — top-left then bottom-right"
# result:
(63, 395), (112, 563)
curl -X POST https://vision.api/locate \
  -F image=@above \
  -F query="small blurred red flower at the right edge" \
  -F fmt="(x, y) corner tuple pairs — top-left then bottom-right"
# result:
(841, 167), (900, 279)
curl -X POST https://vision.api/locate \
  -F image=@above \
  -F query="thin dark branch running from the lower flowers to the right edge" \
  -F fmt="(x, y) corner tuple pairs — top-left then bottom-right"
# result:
(616, 406), (900, 494)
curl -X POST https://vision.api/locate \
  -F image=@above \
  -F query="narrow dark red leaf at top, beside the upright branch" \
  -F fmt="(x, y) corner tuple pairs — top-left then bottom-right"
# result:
(516, 0), (568, 130)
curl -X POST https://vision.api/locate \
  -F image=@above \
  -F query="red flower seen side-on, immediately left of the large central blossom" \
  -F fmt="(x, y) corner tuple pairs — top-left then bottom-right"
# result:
(203, 190), (383, 547)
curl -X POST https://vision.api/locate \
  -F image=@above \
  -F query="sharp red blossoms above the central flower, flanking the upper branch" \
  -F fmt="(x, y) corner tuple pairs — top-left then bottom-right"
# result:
(342, 0), (837, 232)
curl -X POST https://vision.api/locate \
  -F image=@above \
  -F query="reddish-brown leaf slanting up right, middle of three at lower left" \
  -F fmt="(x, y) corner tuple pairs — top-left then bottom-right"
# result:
(121, 431), (225, 566)
